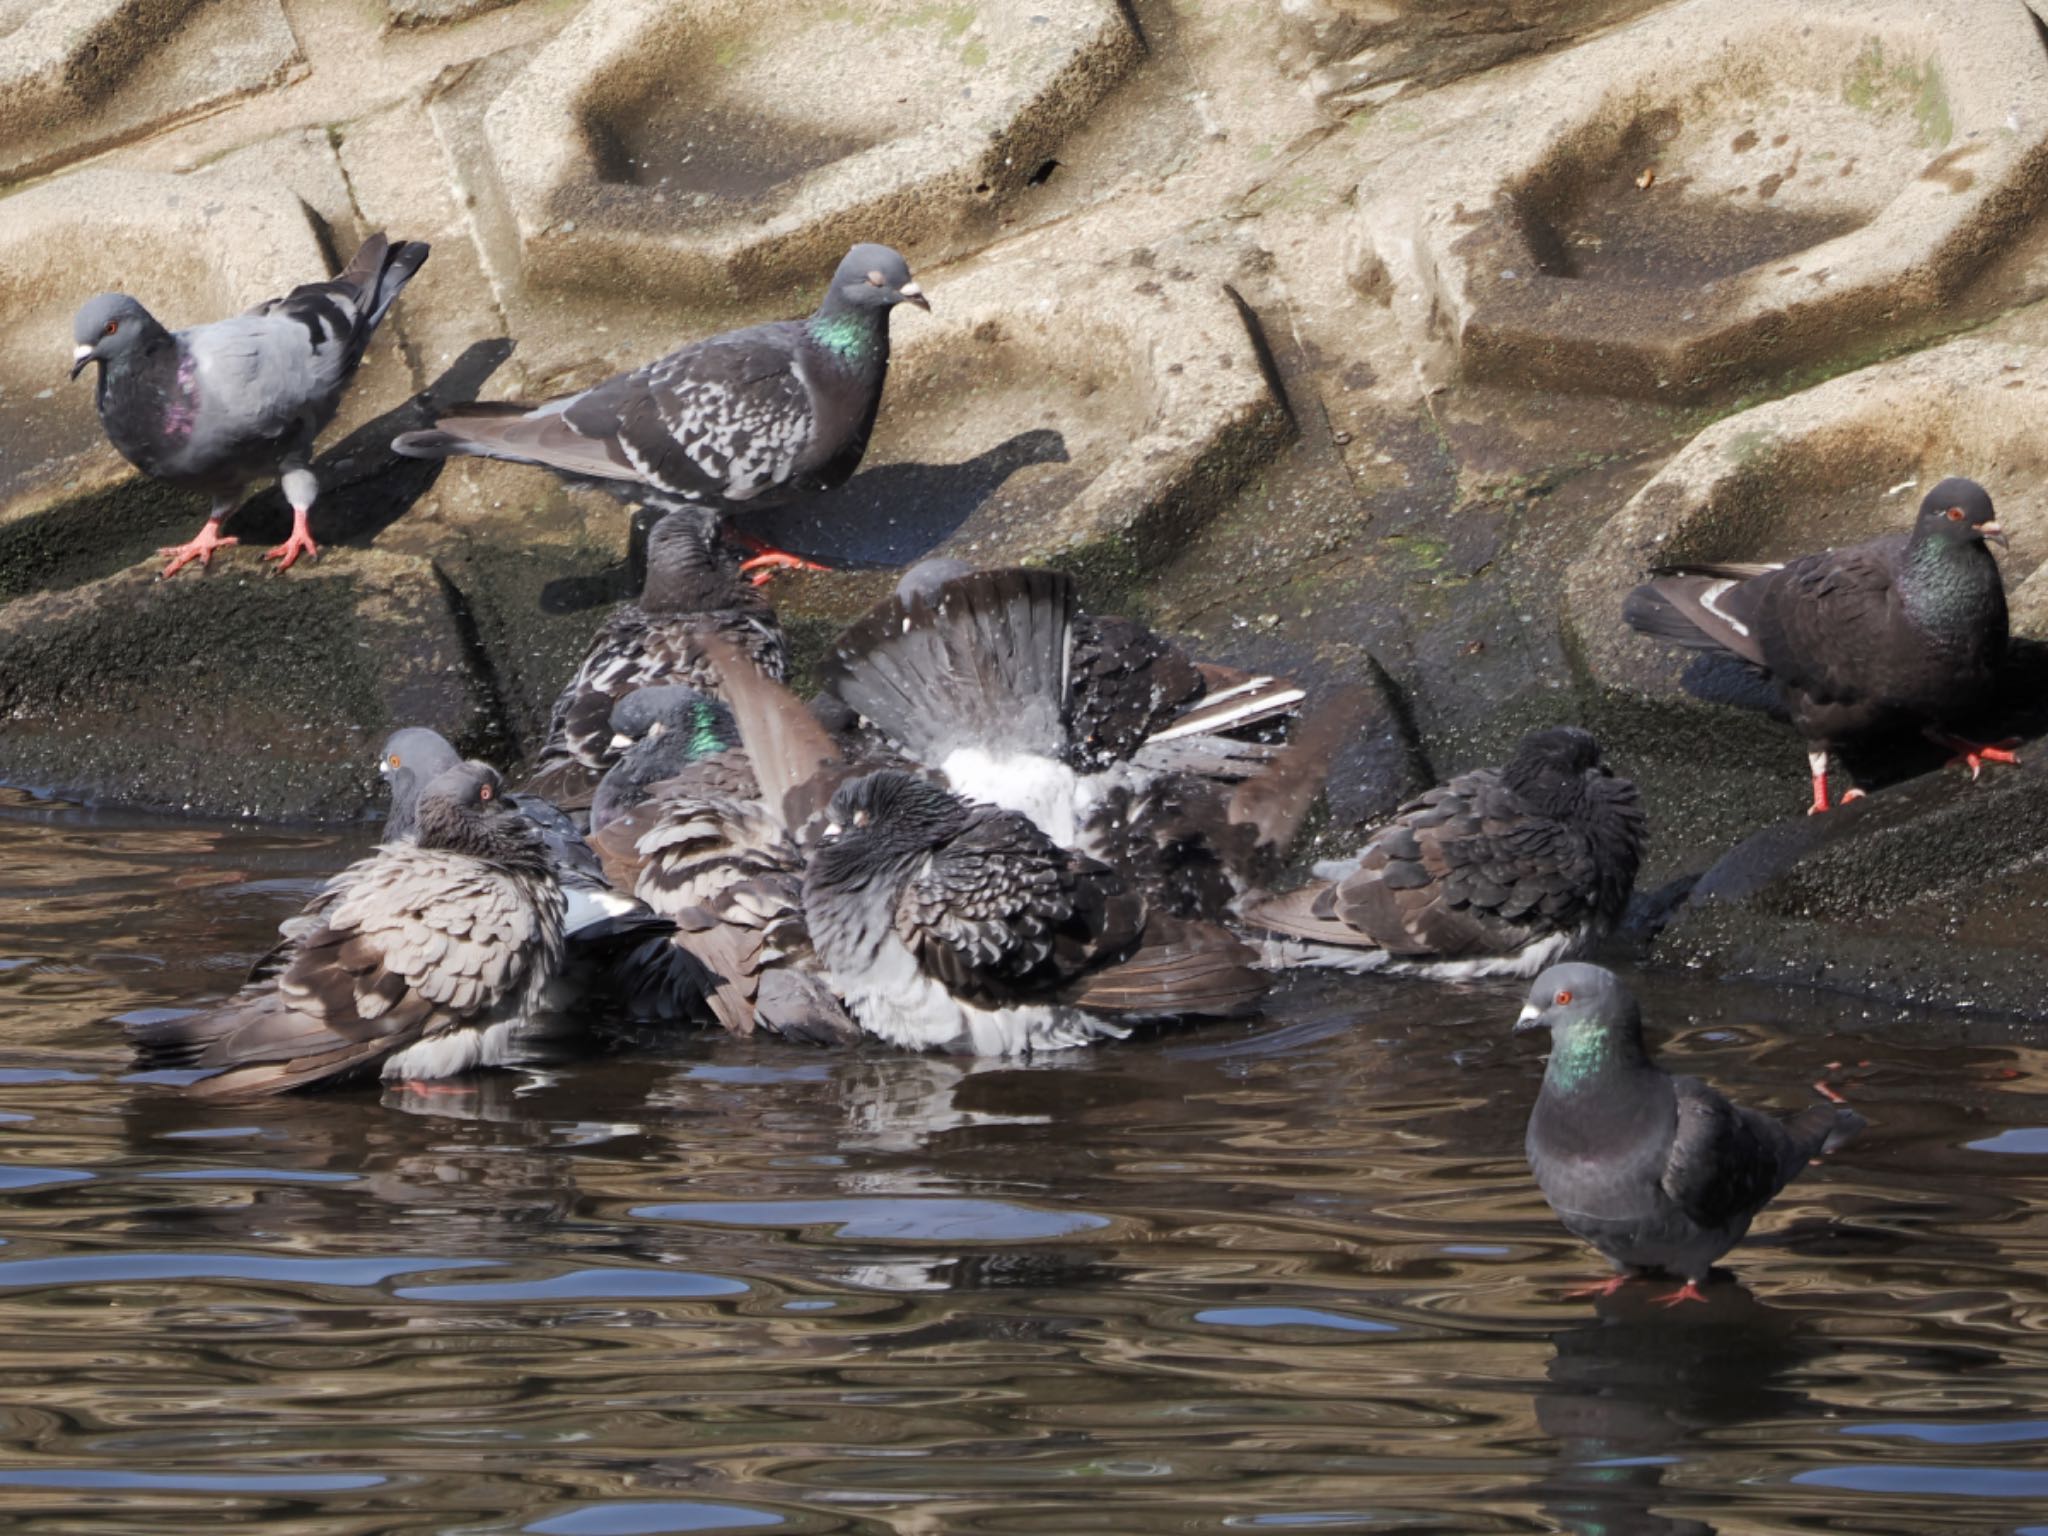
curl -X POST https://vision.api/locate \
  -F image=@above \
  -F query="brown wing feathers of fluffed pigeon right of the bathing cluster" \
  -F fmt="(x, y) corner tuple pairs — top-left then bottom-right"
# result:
(1249, 768), (1597, 958)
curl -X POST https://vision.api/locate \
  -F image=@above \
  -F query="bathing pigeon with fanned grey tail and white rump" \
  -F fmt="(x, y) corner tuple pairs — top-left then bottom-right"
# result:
(823, 561), (1341, 918)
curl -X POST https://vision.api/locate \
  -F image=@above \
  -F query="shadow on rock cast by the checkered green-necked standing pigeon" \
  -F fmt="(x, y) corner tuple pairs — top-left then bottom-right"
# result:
(739, 428), (1069, 569)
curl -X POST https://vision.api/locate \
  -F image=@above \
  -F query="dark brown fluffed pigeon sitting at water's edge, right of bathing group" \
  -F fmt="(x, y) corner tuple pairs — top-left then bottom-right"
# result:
(1245, 725), (1645, 981)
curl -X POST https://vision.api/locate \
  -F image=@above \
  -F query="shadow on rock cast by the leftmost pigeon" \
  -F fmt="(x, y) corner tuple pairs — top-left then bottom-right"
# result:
(229, 336), (514, 547)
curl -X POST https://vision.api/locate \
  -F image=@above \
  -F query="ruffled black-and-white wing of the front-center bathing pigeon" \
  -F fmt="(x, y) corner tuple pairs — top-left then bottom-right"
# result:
(895, 809), (1145, 1006)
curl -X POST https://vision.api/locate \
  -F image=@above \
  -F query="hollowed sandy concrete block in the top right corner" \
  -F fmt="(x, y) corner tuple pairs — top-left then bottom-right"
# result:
(1352, 0), (2048, 399)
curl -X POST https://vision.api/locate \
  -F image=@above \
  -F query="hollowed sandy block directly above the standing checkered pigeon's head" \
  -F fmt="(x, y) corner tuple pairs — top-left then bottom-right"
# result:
(473, 0), (1143, 307)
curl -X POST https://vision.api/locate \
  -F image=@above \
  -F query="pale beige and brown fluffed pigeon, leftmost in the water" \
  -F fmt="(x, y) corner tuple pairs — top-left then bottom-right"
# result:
(129, 762), (565, 1098)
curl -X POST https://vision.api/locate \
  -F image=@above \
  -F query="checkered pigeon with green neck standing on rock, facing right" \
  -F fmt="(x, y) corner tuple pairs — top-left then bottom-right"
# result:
(391, 246), (932, 578)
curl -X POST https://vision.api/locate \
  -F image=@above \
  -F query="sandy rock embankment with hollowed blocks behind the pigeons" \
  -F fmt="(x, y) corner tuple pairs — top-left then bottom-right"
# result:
(0, 0), (2048, 1016)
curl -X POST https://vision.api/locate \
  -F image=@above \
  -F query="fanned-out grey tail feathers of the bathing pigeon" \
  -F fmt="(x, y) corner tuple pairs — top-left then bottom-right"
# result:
(825, 569), (1075, 766)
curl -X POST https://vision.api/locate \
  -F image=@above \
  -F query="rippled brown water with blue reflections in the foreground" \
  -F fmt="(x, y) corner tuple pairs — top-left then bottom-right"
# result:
(0, 793), (2048, 1536)
